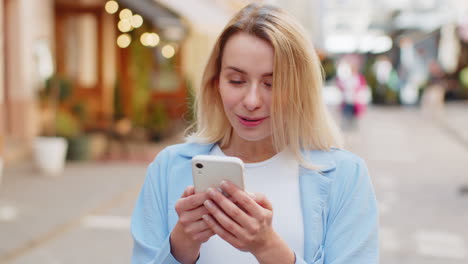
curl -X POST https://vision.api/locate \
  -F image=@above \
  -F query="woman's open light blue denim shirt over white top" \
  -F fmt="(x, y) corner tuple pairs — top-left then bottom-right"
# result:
(131, 143), (379, 264)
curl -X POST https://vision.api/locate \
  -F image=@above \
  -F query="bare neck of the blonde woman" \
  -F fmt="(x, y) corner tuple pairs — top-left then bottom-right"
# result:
(221, 136), (277, 163)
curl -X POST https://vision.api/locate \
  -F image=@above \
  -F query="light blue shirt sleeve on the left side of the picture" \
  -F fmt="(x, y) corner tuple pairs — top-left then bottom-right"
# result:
(131, 153), (179, 264)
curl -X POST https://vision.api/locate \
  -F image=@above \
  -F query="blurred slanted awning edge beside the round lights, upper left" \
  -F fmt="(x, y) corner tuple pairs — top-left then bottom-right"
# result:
(118, 0), (188, 41)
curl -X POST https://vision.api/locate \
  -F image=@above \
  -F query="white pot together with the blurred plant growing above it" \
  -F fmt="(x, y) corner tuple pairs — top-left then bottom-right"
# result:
(33, 75), (71, 176)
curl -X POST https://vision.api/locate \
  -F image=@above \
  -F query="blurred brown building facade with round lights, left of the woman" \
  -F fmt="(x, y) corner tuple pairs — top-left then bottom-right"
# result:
(0, 0), (196, 164)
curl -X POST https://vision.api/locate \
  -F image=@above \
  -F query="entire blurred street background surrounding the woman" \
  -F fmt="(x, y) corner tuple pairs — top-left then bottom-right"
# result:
(0, 0), (468, 264)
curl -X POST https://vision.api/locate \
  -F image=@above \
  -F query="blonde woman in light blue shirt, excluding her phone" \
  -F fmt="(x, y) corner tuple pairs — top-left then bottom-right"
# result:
(132, 4), (378, 264)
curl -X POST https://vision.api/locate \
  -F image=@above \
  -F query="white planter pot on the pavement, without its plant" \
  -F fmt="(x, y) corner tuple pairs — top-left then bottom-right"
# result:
(33, 137), (68, 176)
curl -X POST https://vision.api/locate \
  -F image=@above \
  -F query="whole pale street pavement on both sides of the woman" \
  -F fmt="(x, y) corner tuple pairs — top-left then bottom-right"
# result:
(0, 103), (468, 264)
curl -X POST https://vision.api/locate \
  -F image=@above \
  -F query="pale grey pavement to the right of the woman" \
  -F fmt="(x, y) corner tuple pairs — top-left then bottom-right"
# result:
(346, 102), (468, 264)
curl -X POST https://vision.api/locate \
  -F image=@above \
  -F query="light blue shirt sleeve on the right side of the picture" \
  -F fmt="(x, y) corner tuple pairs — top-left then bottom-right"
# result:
(322, 159), (379, 264)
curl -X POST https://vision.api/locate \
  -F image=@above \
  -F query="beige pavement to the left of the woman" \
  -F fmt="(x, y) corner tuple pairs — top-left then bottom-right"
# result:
(0, 136), (180, 264)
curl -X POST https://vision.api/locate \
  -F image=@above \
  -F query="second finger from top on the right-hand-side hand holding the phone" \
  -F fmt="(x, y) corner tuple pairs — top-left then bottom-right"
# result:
(205, 188), (250, 227)
